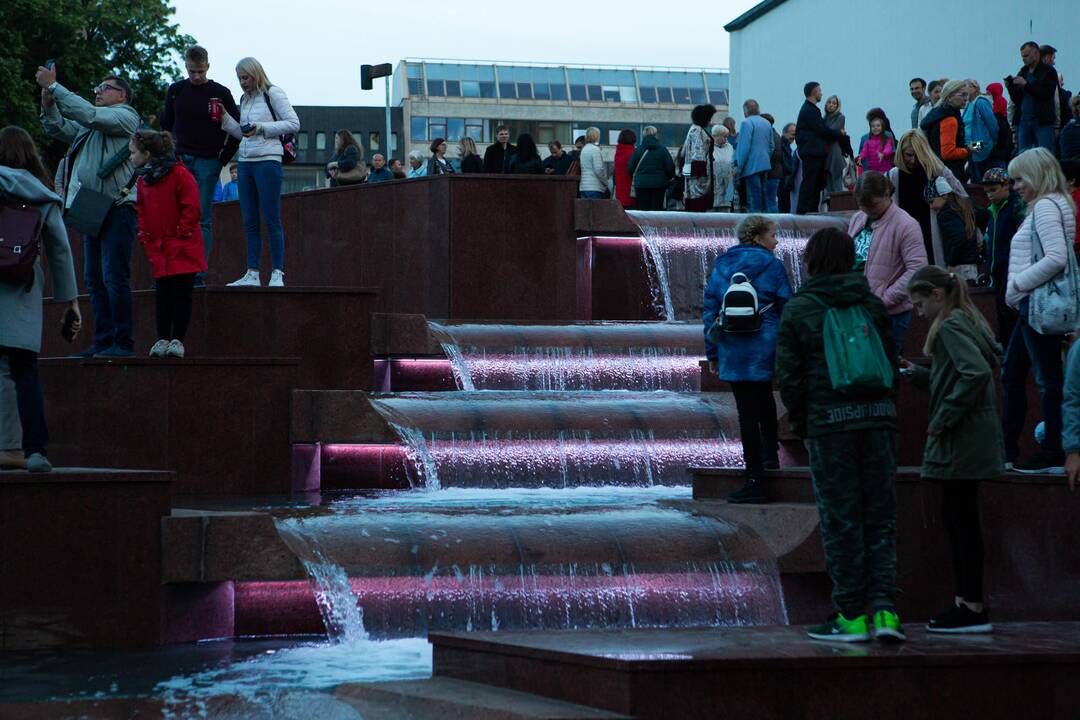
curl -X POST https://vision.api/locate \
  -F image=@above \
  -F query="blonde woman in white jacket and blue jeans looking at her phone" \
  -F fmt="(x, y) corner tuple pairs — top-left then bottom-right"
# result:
(221, 57), (300, 287)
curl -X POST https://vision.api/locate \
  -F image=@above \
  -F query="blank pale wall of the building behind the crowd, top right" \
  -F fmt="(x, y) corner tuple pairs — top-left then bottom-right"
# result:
(730, 0), (1080, 138)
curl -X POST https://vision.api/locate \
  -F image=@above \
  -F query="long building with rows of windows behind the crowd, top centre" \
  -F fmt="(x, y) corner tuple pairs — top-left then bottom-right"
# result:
(392, 59), (728, 160)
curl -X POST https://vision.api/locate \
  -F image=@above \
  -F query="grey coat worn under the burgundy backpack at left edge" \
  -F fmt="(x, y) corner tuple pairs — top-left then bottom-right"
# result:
(0, 165), (78, 353)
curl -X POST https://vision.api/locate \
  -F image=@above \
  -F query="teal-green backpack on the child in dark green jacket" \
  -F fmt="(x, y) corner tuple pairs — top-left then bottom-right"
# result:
(809, 295), (893, 395)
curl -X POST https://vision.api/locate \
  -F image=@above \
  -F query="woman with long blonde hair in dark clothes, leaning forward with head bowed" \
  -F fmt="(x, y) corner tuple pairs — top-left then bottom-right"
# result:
(887, 129), (968, 267)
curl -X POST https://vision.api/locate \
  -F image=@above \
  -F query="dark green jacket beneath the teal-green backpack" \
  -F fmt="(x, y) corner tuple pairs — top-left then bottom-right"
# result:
(777, 272), (896, 437)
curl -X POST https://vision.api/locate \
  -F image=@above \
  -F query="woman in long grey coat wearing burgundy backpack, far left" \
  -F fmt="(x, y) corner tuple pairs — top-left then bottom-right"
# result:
(0, 127), (82, 473)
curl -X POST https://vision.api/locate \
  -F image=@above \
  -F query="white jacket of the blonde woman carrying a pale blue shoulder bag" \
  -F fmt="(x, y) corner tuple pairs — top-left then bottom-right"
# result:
(1005, 194), (1077, 308)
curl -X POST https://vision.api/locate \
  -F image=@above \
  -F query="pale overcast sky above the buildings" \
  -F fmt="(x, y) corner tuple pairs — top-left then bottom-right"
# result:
(174, 0), (757, 105)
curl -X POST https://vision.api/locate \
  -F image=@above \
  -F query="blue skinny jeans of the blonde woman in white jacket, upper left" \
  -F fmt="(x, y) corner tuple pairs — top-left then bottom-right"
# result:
(237, 160), (285, 270)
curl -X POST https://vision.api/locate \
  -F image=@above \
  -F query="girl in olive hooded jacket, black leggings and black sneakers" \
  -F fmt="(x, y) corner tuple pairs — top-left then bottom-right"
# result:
(904, 266), (1004, 634)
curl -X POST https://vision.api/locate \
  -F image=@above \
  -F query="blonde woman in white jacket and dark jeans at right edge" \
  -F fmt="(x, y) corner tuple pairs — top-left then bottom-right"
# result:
(1001, 148), (1076, 473)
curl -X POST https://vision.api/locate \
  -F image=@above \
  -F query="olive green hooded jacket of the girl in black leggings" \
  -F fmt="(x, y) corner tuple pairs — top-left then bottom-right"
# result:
(910, 310), (1004, 480)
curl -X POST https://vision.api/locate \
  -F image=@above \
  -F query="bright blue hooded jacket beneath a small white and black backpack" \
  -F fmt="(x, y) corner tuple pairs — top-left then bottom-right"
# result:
(702, 245), (792, 382)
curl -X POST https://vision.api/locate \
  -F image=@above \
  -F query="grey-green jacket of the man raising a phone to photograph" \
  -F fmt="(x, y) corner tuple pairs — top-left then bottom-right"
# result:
(41, 85), (139, 207)
